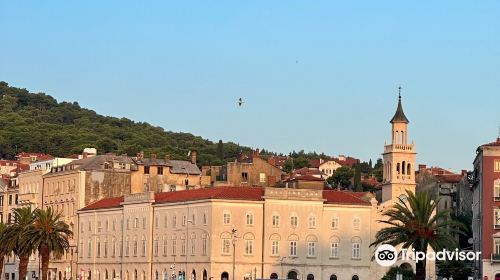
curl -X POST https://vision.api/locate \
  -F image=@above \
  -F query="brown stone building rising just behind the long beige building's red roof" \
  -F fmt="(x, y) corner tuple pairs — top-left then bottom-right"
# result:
(202, 149), (283, 187)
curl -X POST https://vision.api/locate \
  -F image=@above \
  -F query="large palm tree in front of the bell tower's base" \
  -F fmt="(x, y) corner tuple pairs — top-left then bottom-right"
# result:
(370, 191), (465, 280)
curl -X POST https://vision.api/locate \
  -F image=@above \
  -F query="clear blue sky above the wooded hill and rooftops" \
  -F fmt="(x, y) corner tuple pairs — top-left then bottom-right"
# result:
(0, 0), (500, 171)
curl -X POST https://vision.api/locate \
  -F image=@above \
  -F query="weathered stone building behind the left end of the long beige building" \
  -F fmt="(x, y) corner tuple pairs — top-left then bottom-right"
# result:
(41, 153), (135, 280)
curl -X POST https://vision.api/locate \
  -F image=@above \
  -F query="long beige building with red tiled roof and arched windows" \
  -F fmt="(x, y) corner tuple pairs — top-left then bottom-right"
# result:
(78, 187), (384, 280)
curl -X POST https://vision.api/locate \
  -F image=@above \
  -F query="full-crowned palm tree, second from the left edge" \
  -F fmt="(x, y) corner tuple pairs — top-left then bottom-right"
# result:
(21, 207), (73, 280)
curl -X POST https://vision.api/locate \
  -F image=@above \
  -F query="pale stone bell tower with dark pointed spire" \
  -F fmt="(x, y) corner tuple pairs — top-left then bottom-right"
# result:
(382, 87), (416, 202)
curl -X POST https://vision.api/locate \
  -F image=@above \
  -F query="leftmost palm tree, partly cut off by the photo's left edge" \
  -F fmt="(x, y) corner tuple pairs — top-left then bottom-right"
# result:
(0, 207), (34, 280)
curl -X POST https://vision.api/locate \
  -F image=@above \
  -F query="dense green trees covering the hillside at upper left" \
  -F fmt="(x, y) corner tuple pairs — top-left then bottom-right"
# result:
(0, 82), (250, 165)
